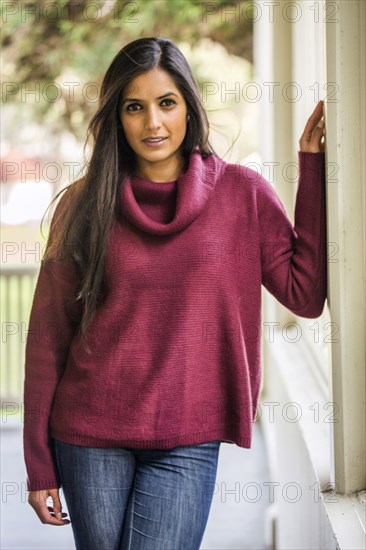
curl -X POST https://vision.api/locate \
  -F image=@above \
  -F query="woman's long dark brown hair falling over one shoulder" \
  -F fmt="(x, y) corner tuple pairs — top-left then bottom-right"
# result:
(41, 37), (217, 344)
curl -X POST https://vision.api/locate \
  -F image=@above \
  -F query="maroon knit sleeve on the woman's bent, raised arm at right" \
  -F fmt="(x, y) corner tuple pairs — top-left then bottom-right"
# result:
(257, 151), (327, 318)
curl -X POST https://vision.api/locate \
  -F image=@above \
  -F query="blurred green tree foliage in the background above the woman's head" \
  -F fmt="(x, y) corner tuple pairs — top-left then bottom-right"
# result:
(1, 0), (254, 140)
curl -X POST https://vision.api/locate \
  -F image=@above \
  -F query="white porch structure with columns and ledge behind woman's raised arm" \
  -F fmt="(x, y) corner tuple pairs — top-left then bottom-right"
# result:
(254, 0), (366, 550)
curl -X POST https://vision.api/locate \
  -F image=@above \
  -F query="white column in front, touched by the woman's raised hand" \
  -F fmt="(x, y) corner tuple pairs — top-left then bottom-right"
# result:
(322, 0), (366, 493)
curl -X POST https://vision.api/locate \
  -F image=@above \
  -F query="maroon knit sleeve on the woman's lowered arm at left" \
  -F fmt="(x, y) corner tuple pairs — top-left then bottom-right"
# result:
(23, 191), (78, 491)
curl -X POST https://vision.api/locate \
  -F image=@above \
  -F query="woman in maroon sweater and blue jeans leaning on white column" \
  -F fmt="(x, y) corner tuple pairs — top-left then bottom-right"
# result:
(24, 38), (326, 550)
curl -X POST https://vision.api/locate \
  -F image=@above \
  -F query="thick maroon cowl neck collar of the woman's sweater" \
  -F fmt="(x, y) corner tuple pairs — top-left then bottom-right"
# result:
(121, 147), (219, 235)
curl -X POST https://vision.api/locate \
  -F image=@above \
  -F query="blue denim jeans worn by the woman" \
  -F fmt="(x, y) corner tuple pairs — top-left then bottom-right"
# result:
(53, 439), (220, 550)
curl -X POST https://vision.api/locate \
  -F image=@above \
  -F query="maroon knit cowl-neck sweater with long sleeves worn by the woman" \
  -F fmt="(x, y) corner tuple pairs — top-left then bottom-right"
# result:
(24, 148), (327, 490)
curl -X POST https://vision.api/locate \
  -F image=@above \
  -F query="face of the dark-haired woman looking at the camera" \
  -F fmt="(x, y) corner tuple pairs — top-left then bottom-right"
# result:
(120, 68), (187, 179)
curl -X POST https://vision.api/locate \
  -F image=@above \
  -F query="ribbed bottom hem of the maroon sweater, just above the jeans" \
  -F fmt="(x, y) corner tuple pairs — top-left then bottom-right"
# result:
(51, 430), (251, 449)
